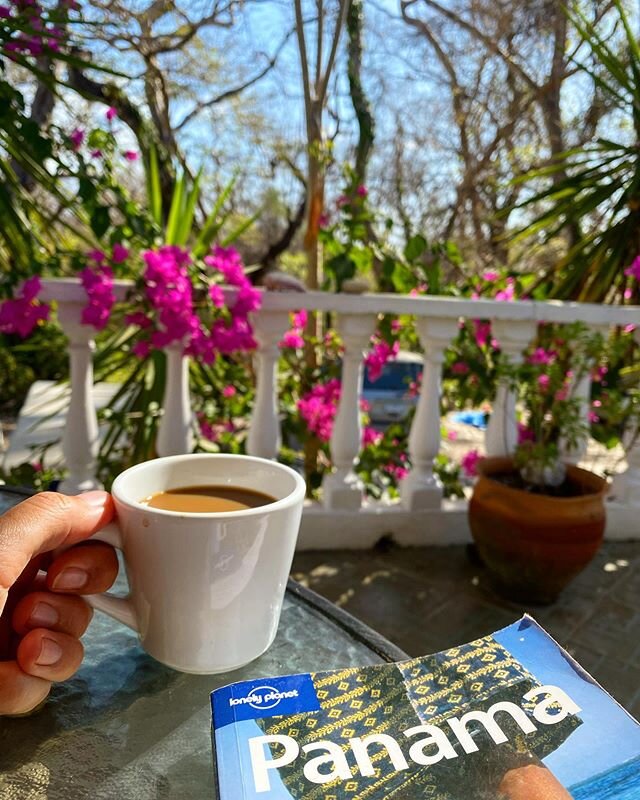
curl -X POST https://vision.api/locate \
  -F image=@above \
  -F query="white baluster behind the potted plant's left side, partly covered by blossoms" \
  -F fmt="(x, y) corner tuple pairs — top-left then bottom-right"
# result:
(485, 320), (536, 456)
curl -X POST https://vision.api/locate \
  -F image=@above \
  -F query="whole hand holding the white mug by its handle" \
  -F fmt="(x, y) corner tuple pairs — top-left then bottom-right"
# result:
(0, 492), (118, 715)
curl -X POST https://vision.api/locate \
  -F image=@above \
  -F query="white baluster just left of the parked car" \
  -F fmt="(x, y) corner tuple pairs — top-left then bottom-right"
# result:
(322, 314), (375, 511)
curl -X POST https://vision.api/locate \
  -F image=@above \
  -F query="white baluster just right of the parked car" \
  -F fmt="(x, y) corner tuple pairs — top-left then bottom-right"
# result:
(400, 319), (458, 511)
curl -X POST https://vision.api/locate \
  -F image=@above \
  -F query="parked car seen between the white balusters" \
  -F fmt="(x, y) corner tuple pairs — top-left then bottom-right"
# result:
(362, 350), (423, 427)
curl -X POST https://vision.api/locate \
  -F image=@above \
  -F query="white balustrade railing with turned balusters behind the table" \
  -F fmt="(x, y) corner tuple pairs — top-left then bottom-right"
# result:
(28, 279), (640, 548)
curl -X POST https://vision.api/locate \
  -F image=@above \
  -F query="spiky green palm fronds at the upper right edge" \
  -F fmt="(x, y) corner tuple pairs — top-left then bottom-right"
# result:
(512, 0), (640, 302)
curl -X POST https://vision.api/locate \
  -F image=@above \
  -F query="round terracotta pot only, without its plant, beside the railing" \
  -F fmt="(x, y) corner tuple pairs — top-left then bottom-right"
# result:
(469, 458), (607, 603)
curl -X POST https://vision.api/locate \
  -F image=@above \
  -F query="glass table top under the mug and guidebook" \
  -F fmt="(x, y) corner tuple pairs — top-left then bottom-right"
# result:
(0, 488), (403, 800)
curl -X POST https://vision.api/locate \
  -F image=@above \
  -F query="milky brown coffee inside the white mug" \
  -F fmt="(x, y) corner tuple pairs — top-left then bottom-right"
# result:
(140, 485), (276, 514)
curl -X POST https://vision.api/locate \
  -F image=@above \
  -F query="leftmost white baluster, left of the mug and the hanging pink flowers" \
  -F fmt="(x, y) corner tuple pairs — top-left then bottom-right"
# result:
(58, 302), (101, 494)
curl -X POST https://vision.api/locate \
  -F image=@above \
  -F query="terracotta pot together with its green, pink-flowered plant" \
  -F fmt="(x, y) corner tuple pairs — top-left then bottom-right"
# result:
(469, 324), (607, 603)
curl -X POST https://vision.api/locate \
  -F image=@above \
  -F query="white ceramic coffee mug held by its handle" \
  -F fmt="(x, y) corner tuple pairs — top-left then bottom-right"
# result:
(87, 454), (305, 674)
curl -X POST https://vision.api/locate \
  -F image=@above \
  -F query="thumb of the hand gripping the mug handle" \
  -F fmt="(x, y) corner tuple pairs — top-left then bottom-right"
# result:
(0, 492), (114, 613)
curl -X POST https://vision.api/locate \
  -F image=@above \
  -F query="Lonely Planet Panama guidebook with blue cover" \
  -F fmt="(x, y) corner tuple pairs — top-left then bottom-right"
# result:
(211, 616), (640, 800)
